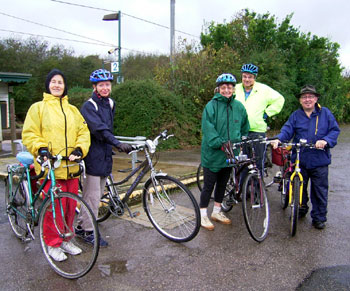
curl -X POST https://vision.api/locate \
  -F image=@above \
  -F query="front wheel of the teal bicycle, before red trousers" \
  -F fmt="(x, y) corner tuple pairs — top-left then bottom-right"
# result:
(39, 192), (100, 279)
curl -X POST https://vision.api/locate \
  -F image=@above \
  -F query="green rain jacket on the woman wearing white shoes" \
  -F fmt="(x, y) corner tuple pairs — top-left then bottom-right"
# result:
(201, 93), (249, 172)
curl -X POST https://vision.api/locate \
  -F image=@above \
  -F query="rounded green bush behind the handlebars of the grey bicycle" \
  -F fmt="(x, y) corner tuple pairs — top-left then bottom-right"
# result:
(112, 80), (199, 148)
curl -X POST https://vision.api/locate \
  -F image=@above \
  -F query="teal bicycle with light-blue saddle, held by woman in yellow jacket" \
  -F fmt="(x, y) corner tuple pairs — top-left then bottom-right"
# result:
(5, 152), (99, 279)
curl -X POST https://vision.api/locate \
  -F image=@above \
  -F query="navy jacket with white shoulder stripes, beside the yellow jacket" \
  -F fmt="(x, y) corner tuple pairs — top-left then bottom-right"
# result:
(81, 92), (120, 177)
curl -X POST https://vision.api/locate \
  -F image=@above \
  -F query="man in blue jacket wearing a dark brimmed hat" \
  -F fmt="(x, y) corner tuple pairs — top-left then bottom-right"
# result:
(273, 85), (340, 229)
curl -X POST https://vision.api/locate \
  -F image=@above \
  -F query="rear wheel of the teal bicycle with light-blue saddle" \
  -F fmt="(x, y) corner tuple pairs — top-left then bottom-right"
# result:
(5, 176), (29, 240)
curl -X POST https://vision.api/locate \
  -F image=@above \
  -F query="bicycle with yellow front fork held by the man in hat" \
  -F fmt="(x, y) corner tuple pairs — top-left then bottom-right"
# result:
(276, 139), (315, 236)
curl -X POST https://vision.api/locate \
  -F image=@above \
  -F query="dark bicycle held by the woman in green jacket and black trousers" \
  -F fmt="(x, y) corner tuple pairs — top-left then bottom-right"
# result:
(196, 138), (270, 242)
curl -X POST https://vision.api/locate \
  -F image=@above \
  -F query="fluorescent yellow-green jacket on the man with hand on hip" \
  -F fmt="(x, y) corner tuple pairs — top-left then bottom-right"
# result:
(235, 82), (284, 132)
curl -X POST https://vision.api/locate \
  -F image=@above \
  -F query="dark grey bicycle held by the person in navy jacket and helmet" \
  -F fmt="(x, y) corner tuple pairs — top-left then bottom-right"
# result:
(97, 130), (200, 242)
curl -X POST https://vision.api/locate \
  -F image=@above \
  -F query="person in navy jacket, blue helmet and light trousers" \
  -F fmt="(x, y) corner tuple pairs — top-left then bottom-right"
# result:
(76, 69), (132, 246)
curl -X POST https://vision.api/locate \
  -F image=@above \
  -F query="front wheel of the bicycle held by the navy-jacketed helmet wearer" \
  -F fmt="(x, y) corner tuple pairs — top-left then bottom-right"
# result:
(143, 176), (200, 242)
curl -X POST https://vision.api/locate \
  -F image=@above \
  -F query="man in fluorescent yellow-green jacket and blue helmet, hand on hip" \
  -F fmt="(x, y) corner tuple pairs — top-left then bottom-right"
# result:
(236, 64), (284, 170)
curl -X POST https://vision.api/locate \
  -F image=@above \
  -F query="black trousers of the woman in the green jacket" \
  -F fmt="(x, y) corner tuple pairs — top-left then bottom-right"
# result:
(199, 167), (231, 208)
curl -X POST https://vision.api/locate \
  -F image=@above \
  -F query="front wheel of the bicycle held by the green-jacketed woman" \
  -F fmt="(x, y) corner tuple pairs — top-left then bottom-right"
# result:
(242, 173), (269, 242)
